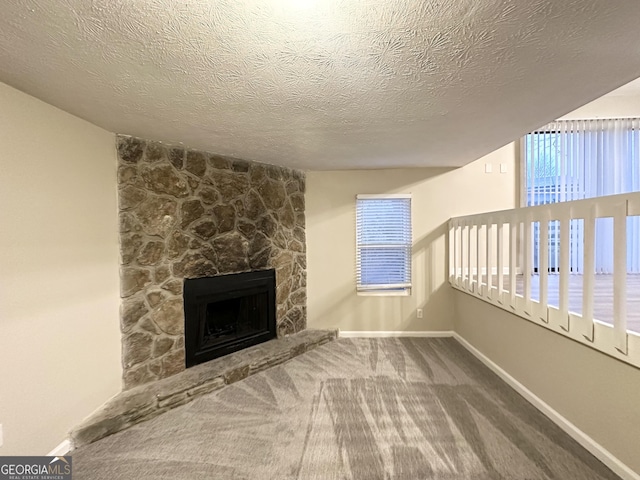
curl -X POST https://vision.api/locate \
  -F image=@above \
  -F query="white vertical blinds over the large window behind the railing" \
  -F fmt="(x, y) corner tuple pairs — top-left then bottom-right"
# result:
(524, 118), (640, 273)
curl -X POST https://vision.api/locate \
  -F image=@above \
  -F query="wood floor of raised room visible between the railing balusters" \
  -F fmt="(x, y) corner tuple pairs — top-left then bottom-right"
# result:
(483, 274), (640, 334)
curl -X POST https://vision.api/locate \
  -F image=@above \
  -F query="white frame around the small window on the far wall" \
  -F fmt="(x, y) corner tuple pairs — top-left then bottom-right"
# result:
(355, 193), (413, 297)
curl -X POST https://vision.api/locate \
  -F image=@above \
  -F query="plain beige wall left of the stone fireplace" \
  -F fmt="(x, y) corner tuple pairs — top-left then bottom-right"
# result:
(0, 84), (121, 455)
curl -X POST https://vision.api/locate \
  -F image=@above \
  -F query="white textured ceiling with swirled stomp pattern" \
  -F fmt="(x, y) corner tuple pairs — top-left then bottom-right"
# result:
(0, 0), (640, 169)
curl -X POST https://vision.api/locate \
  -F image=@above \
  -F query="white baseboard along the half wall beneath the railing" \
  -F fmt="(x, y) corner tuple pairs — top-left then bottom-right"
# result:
(453, 332), (640, 480)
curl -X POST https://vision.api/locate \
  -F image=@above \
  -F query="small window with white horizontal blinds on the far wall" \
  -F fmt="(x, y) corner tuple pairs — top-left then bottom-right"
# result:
(356, 195), (411, 295)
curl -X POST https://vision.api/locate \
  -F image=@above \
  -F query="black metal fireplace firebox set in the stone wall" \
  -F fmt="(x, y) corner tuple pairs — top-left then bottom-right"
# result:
(183, 270), (276, 368)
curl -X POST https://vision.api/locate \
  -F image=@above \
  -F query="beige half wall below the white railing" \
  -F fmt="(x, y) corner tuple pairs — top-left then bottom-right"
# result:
(453, 291), (640, 472)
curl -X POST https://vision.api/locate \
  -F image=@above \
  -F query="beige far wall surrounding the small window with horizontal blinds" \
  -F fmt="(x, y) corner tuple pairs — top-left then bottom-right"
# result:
(306, 144), (516, 331)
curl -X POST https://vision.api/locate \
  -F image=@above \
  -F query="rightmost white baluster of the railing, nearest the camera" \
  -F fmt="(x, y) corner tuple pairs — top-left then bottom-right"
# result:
(613, 202), (628, 354)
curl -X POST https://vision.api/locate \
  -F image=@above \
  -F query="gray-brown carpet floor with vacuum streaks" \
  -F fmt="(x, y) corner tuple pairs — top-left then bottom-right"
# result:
(73, 338), (618, 480)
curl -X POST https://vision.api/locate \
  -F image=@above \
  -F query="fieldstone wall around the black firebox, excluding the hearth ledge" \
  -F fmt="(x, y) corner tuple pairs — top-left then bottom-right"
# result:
(117, 136), (306, 389)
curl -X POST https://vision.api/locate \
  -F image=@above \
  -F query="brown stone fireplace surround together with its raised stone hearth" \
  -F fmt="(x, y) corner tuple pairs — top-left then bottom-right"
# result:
(69, 135), (338, 448)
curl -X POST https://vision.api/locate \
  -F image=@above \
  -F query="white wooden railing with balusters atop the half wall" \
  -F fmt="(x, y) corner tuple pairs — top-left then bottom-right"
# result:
(449, 193), (640, 367)
